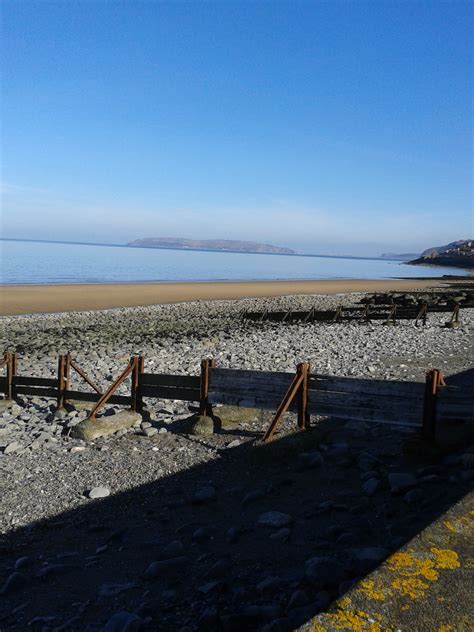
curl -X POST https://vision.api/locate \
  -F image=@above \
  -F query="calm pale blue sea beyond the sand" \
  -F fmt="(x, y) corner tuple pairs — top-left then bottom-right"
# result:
(0, 241), (465, 284)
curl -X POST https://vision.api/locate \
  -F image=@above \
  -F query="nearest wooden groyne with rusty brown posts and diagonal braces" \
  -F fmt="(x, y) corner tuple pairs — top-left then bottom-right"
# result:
(0, 352), (474, 441)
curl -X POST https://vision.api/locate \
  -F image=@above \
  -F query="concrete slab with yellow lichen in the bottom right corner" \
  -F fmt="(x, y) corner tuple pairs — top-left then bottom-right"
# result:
(299, 492), (474, 632)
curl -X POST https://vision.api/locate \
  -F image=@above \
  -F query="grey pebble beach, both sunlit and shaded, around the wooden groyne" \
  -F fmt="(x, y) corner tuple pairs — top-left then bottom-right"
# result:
(0, 292), (474, 632)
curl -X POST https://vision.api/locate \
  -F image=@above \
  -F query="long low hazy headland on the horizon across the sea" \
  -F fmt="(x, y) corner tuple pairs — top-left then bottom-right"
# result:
(127, 237), (296, 255)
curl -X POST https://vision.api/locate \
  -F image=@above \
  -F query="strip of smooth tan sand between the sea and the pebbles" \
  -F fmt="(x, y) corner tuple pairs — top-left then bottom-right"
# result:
(0, 279), (439, 316)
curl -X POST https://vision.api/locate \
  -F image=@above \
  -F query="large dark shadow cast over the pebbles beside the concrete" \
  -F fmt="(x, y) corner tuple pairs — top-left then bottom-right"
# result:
(0, 375), (472, 631)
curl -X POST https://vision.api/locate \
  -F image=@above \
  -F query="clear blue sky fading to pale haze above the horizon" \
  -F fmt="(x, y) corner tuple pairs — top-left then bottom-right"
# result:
(0, 0), (474, 255)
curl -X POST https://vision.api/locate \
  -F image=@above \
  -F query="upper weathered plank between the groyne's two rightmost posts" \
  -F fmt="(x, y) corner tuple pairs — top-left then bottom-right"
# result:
(308, 375), (425, 399)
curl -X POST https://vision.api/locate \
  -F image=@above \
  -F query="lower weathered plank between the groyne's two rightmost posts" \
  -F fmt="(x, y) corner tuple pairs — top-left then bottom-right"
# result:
(309, 391), (423, 416)
